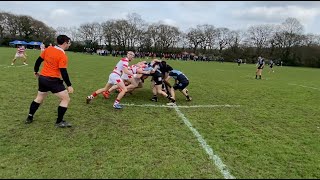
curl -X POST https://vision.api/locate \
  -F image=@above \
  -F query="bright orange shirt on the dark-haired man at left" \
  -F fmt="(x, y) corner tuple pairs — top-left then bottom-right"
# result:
(40, 46), (68, 78)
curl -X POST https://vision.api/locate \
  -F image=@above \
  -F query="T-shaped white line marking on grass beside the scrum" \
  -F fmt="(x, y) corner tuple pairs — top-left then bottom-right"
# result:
(122, 104), (236, 179)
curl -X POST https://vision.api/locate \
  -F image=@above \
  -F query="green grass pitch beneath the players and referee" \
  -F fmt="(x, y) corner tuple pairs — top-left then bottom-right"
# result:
(0, 48), (320, 179)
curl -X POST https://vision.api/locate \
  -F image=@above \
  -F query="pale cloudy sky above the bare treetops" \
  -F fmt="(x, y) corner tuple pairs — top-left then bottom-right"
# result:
(0, 1), (320, 34)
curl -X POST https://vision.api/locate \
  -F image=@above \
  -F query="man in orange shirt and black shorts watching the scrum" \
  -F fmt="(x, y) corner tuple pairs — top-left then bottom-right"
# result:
(26, 35), (73, 128)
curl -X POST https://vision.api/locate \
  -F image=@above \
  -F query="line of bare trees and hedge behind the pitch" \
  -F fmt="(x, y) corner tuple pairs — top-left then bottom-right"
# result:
(0, 12), (320, 67)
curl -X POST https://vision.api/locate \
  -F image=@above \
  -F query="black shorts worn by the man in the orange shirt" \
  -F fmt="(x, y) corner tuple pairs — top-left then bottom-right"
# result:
(38, 76), (66, 93)
